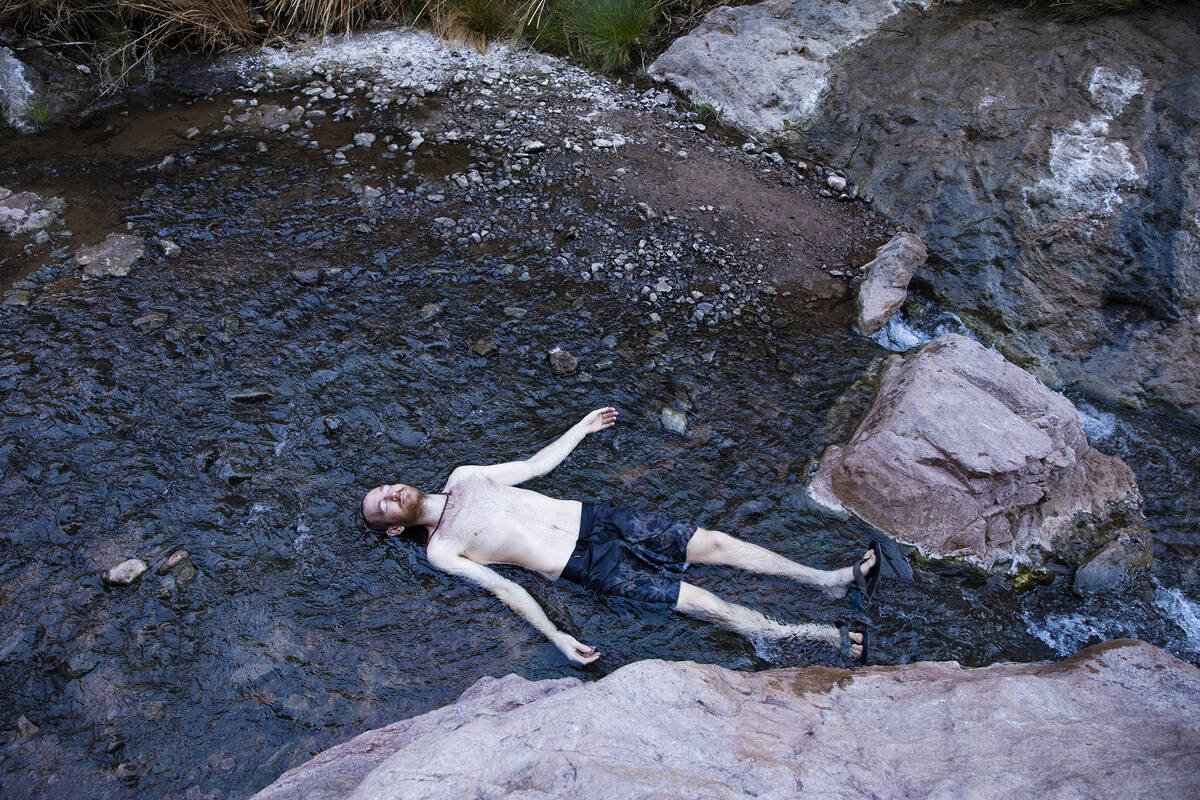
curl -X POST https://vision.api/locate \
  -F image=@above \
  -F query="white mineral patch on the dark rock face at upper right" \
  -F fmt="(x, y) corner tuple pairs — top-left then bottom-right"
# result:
(1022, 67), (1144, 225)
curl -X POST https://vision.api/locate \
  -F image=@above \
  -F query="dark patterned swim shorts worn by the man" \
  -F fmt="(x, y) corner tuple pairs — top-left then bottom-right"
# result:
(559, 503), (696, 606)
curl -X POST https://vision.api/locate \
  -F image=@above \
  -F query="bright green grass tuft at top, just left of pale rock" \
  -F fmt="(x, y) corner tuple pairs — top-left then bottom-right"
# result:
(568, 0), (659, 72)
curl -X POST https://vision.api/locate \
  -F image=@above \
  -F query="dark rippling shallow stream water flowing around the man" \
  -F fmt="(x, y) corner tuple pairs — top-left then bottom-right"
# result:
(0, 77), (1200, 798)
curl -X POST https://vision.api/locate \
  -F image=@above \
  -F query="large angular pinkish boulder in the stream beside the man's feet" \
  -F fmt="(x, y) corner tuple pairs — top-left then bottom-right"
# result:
(814, 333), (1147, 569)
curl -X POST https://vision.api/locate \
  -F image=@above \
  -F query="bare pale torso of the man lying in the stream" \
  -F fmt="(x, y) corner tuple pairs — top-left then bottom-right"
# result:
(430, 471), (582, 581)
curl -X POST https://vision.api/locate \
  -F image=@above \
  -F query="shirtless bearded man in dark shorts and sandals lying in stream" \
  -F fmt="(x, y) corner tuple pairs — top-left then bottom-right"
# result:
(362, 408), (877, 664)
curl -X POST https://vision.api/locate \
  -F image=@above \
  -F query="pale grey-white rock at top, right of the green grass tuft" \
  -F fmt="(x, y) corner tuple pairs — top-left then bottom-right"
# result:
(650, 0), (929, 134)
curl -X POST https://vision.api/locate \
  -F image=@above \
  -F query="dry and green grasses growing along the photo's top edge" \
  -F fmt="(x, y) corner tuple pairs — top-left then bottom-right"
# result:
(0, 0), (1180, 86)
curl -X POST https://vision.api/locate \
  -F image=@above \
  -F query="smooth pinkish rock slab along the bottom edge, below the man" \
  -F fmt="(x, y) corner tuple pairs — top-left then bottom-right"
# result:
(254, 640), (1200, 800)
